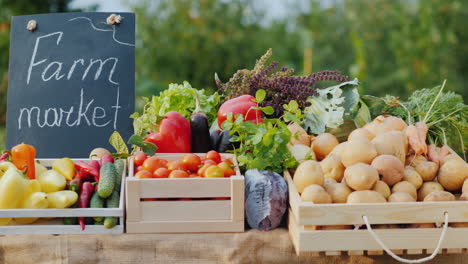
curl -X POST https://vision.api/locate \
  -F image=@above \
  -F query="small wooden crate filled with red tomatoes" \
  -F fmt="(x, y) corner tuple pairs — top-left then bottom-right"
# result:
(126, 153), (244, 233)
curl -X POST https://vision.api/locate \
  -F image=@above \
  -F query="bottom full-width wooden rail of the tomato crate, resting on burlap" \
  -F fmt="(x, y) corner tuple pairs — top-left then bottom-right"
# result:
(126, 221), (244, 234)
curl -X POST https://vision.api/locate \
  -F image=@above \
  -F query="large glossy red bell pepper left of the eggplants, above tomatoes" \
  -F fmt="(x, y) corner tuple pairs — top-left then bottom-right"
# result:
(145, 112), (192, 153)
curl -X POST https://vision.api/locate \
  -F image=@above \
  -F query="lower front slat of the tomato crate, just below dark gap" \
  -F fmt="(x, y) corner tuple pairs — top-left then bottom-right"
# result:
(140, 200), (231, 222)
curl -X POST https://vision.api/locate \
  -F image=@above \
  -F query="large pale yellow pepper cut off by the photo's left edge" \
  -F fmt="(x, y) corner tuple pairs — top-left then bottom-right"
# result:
(0, 168), (29, 225)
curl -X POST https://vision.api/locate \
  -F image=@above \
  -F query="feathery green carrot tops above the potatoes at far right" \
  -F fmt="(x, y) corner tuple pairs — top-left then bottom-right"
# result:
(384, 82), (468, 159)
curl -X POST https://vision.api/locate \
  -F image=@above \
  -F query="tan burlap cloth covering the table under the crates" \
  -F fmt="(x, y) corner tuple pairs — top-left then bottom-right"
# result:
(0, 228), (468, 264)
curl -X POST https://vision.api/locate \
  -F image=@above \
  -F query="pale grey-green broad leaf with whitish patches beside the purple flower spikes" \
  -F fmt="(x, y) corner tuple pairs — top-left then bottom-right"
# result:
(304, 79), (359, 134)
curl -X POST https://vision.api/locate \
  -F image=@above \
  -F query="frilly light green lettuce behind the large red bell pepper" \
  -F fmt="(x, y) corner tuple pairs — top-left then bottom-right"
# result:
(130, 81), (220, 135)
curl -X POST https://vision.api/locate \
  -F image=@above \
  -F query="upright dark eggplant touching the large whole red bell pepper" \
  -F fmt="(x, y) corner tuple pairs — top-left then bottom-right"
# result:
(190, 94), (212, 153)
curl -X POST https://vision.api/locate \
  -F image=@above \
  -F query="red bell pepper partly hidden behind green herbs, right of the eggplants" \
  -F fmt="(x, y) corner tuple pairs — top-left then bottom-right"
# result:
(218, 95), (263, 128)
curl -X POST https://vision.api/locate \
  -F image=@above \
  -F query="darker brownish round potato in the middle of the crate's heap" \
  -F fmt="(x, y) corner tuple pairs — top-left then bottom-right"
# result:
(371, 154), (405, 186)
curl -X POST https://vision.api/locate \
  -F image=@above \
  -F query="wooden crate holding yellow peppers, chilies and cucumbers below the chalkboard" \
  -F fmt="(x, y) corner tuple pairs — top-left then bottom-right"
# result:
(0, 159), (127, 235)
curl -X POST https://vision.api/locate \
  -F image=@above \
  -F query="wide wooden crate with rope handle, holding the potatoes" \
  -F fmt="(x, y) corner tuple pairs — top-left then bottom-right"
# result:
(284, 171), (468, 257)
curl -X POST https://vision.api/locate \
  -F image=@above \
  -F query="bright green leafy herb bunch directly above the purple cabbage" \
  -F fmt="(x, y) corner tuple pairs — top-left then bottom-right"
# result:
(223, 90), (303, 173)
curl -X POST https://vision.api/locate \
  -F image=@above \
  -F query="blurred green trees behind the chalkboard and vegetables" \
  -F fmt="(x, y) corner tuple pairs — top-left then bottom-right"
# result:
(0, 0), (468, 149)
